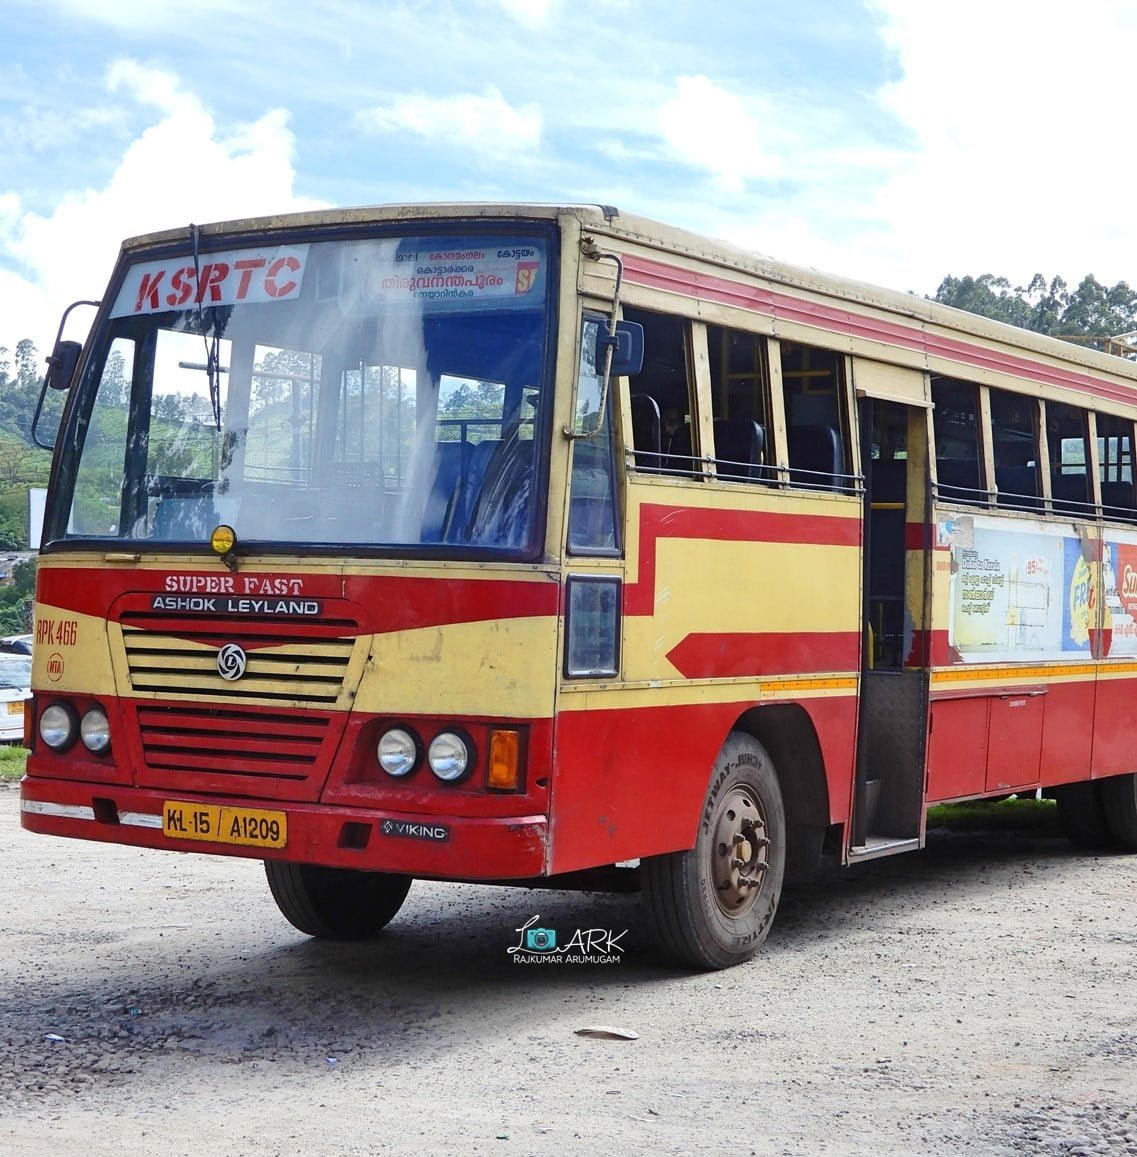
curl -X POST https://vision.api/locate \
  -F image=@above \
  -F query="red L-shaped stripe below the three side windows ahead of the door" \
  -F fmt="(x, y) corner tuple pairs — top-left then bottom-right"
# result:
(623, 504), (861, 616)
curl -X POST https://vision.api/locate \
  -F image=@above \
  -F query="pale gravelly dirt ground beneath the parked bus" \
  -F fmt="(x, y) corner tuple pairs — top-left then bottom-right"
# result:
(0, 786), (1137, 1157)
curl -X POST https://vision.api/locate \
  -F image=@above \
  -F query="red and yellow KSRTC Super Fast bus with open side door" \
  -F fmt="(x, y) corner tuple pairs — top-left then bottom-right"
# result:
(21, 205), (1137, 970)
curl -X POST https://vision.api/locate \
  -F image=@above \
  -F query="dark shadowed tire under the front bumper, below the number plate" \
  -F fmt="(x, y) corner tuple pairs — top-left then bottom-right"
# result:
(265, 860), (411, 941)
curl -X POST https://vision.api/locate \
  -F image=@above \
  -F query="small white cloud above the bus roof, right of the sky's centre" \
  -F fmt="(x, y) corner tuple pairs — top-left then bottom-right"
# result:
(659, 76), (781, 192)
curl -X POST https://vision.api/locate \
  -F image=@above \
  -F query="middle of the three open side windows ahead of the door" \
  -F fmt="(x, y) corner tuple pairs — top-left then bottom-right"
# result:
(707, 325), (777, 481)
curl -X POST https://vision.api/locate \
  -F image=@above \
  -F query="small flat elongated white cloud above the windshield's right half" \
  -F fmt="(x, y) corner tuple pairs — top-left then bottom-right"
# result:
(356, 84), (541, 160)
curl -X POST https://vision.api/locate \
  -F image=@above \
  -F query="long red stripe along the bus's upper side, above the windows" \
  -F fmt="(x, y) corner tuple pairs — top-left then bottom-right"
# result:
(623, 257), (1137, 401)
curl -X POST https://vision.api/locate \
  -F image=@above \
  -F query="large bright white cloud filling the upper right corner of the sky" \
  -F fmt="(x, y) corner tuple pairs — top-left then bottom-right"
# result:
(860, 0), (1137, 289)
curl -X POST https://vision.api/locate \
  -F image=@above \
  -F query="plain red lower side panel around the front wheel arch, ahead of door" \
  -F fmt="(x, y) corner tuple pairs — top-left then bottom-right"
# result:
(549, 688), (856, 874)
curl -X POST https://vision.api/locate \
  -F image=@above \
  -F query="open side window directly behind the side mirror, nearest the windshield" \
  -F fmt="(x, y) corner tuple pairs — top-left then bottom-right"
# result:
(623, 307), (702, 478)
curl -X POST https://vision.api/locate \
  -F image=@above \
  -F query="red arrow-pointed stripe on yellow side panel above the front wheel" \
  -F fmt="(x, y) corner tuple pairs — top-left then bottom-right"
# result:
(667, 631), (861, 679)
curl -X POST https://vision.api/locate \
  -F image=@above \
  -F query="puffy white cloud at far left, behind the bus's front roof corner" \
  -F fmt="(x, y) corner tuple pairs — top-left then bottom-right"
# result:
(0, 61), (316, 353)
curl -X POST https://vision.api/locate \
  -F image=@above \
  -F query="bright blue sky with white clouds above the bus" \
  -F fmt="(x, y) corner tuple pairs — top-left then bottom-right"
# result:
(0, 0), (1137, 358)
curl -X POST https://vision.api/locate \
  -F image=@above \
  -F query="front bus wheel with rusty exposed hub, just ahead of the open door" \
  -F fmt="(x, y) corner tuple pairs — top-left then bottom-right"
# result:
(641, 731), (785, 970)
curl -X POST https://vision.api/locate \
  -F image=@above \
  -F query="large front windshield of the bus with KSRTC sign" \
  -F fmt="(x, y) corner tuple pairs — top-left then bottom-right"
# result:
(47, 231), (553, 552)
